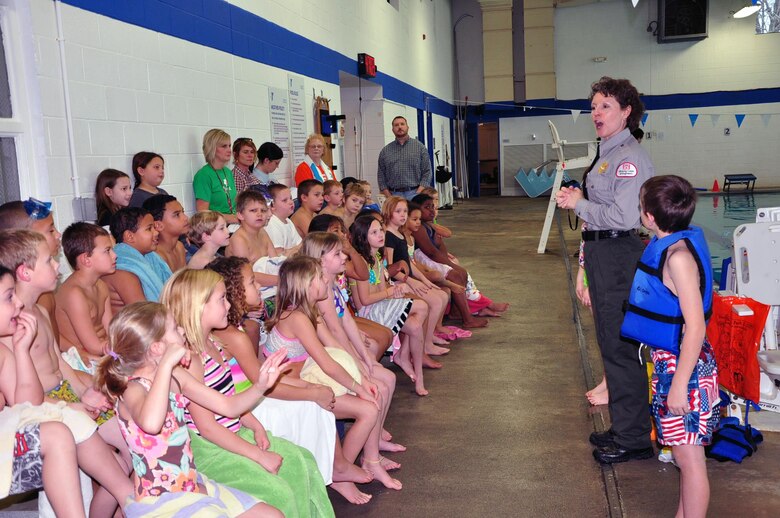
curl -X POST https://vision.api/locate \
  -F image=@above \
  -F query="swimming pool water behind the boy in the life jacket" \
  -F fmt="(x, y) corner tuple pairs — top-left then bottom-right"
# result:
(693, 192), (780, 284)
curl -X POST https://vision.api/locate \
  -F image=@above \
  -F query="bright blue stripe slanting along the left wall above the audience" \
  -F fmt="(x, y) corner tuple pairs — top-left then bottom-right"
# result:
(63, 0), (454, 118)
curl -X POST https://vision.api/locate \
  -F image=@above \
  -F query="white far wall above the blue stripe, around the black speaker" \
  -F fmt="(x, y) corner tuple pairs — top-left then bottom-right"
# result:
(555, 0), (780, 99)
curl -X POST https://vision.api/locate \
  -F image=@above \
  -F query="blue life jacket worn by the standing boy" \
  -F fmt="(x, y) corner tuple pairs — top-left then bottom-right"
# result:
(620, 227), (712, 354)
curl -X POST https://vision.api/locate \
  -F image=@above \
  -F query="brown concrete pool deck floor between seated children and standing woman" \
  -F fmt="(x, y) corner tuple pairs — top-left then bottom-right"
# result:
(0, 198), (780, 518)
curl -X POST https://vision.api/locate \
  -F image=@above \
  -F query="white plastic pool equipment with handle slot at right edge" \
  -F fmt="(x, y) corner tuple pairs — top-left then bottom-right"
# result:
(733, 208), (780, 412)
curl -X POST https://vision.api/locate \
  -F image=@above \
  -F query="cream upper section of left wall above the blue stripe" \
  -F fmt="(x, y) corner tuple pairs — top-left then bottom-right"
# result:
(229, 0), (453, 100)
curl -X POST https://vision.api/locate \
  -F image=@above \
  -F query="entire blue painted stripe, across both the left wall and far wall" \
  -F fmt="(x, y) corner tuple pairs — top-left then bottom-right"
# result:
(62, 0), (780, 122)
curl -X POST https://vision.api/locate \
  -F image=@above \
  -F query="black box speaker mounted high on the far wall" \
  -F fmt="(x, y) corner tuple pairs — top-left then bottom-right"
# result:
(658, 0), (707, 43)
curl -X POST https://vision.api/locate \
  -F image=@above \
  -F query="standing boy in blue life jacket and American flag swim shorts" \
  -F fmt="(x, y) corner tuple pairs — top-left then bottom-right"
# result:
(621, 176), (719, 518)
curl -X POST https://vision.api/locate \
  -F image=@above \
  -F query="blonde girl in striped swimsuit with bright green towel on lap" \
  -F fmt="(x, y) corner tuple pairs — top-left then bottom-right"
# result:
(161, 269), (333, 517)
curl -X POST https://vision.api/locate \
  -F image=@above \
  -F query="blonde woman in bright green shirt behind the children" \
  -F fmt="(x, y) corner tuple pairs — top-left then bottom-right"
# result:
(192, 128), (238, 223)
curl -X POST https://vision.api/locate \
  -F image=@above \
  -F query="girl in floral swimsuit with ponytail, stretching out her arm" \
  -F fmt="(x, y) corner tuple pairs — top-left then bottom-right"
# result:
(97, 302), (283, 517)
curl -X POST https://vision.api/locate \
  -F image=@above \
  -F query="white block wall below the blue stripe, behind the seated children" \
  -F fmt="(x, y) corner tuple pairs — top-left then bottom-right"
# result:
(31, 0), (341, 232)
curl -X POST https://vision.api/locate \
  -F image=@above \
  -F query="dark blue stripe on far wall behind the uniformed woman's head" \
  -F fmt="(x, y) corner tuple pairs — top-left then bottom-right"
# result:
(468, 88), (780, 122)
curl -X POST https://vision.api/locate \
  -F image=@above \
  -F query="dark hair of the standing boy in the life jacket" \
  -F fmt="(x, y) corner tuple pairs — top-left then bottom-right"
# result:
(639, 175), (696, 232)
